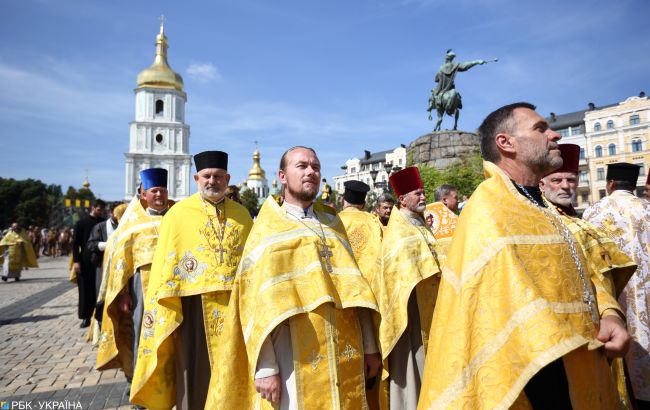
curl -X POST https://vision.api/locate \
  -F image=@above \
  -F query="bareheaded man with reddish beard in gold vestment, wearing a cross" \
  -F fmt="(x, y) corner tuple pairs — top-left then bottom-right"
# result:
(206, 147), (381, 409)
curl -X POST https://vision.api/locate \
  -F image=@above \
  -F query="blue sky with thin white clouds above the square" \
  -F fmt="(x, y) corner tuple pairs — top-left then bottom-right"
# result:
(0, 0), (650, 200)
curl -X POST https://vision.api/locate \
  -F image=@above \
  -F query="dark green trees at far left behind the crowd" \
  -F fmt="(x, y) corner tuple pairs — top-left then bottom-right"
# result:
(0, 178), (61, 227)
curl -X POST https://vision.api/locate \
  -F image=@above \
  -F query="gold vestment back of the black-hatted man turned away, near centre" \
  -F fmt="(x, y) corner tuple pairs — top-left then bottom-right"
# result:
(339, 207), (383, 282)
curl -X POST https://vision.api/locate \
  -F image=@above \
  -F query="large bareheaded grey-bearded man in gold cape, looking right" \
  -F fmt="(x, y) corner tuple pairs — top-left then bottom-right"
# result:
(419, 103), (629, 409)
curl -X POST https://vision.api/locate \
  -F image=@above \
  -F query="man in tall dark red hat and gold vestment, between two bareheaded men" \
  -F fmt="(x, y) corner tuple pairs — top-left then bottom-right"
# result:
(371, 167), (443, 409)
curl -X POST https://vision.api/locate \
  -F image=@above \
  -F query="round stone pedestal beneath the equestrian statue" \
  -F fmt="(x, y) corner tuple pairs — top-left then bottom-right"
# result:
(406, 131), (480, 169)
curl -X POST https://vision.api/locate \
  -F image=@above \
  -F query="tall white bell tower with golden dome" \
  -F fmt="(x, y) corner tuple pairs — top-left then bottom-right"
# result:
(124, 22), (192, 200)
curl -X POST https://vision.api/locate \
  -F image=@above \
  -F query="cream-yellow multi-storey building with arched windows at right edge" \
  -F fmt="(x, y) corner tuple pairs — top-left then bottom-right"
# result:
(585, 93), (650, 202)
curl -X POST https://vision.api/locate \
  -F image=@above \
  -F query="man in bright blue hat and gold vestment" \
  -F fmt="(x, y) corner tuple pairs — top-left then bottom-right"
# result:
(96, 168), (169, 381)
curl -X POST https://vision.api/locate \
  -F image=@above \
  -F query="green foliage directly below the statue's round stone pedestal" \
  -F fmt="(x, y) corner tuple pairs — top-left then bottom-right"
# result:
(419, 153), (485, 203)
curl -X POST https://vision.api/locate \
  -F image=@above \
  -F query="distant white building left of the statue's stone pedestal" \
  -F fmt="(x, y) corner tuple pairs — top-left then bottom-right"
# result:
(332, 145), (406, 195)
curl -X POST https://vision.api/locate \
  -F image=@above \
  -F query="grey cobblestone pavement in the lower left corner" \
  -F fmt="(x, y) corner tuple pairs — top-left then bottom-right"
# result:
(0, 257), (131, 409)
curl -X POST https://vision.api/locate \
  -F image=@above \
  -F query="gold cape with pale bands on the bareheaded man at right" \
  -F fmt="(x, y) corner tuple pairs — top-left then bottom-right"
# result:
(418, 162), (618, 409)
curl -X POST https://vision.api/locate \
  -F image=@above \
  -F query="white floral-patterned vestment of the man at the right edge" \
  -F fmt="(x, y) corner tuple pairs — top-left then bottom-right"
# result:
(583, 190), (650, 401)
